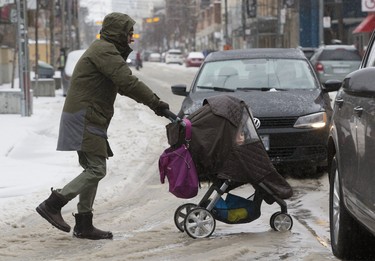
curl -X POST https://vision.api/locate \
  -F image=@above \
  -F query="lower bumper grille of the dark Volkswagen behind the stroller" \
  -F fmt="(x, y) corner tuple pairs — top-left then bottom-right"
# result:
(268, 146), (327, 162)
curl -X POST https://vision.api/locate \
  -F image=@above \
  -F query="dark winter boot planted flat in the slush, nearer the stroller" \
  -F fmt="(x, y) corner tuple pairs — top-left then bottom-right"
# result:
(73, 212), (113, 240)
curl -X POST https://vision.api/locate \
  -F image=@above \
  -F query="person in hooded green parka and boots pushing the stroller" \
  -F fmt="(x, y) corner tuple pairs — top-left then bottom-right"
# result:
(36, 12), (169, 239)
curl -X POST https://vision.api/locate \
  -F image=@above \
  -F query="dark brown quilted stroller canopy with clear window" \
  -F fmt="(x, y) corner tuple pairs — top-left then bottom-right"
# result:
(167, 95), (293, 199)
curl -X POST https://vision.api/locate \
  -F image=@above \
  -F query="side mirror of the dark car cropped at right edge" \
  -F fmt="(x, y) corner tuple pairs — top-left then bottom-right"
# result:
(342, 67), (375, 95)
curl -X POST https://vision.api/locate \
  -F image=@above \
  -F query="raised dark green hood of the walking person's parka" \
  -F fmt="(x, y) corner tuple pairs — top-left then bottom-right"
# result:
(100, 12), (135, 57)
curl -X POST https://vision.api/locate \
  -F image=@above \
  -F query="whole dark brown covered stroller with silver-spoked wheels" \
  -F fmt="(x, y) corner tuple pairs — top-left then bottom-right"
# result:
(166, 95), (293, 238)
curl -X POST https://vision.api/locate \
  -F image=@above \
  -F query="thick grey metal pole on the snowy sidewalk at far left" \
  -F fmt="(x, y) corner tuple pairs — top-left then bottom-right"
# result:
(16, 0), (31, 116)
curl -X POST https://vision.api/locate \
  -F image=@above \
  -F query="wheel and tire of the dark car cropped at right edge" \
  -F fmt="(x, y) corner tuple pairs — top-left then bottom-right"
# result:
(329, 156), (375, 260)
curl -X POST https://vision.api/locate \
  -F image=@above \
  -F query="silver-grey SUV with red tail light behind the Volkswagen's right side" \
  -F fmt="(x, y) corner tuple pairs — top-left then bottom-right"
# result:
(310, 44), (362, 84)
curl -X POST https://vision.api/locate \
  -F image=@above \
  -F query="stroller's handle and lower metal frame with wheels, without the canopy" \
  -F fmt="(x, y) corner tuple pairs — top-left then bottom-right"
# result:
(165, 96), (293, 238)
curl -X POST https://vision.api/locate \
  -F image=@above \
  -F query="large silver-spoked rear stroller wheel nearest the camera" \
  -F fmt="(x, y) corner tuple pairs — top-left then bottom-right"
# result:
(184, 207), (216, 238)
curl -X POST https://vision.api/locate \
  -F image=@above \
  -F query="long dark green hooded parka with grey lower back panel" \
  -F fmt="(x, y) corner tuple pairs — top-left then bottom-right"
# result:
(57, 13), (159, 157)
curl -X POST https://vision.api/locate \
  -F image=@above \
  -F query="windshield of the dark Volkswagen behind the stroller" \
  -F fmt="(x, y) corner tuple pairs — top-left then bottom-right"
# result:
(194, 59), (318, 92)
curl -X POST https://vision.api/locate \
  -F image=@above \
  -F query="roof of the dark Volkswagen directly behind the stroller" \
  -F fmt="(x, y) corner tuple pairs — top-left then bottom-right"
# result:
(205, 48), (307, 62)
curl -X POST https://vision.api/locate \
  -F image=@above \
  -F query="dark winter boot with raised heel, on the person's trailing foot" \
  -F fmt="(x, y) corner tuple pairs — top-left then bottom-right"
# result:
(36, 189), (70, 232)
